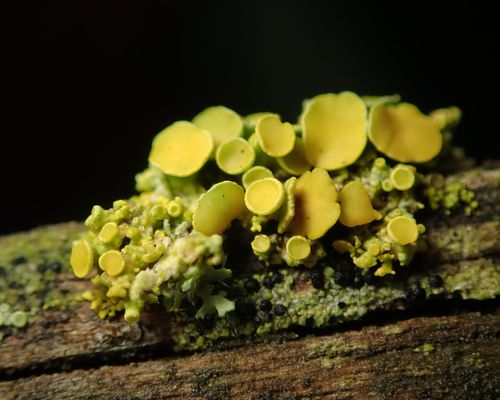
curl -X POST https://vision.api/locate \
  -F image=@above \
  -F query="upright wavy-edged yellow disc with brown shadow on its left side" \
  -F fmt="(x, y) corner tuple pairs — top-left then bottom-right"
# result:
(288, 168), (340, 239)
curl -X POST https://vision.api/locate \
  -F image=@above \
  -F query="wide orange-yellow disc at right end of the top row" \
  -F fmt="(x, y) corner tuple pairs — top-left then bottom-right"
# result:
(368, 103), (443, 163)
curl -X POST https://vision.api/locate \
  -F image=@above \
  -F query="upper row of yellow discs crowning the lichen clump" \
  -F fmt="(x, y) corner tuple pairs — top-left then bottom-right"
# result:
(149, 92), (442, 177)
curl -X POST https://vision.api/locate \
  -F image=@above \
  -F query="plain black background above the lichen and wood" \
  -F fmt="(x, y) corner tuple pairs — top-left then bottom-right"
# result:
(4, 0), (499, 233)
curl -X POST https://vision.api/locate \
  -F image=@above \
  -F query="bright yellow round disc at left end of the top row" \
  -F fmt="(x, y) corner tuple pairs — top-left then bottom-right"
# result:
(149, 121), (214, 177)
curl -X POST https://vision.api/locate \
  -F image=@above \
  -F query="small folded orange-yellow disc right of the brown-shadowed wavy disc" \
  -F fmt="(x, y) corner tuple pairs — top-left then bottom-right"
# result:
(339, 181), (381, 227)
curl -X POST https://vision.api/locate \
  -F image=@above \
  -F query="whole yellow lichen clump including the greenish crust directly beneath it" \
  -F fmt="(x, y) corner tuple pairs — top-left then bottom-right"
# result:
(41, 92), (493, 348)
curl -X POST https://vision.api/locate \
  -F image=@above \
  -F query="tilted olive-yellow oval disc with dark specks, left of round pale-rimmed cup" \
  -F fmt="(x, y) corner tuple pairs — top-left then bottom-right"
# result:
(193, 181), (245, 236)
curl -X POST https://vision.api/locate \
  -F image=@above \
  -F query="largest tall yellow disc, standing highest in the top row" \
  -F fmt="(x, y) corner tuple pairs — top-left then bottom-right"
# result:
(301, 92), (367, 170)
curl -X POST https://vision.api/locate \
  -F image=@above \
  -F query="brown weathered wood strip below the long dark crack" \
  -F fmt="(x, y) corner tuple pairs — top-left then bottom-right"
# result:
(0, 314), (500, 400)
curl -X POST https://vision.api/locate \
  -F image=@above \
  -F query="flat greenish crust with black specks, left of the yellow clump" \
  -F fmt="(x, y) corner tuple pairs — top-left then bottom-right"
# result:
(0, 223), (83, 341)
